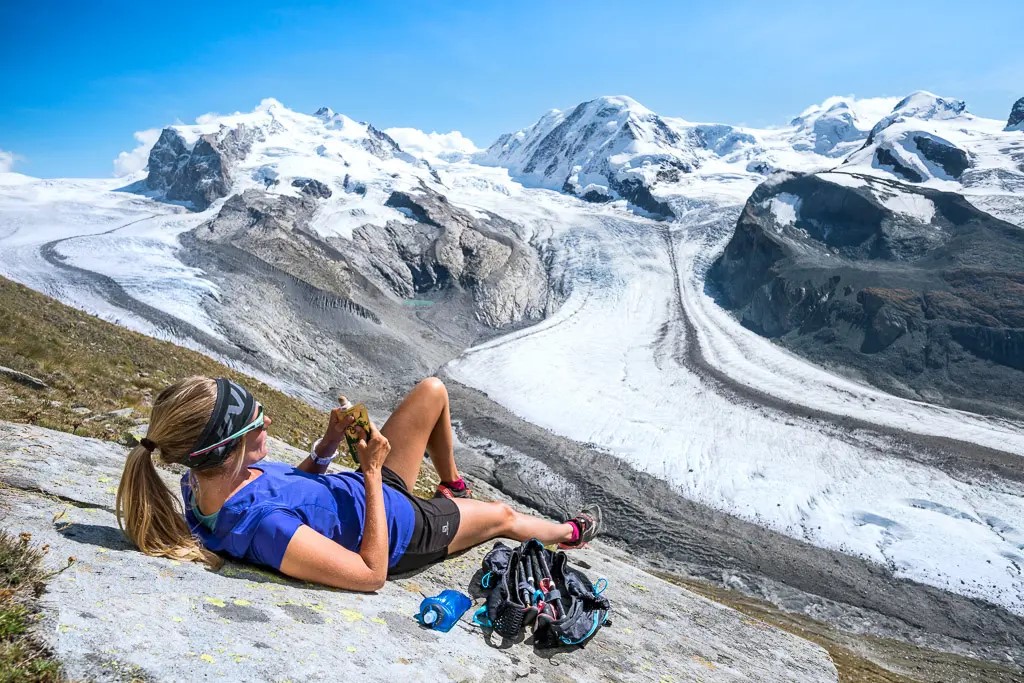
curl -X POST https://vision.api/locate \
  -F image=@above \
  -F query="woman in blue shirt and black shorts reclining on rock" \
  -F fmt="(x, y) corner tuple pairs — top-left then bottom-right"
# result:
(116, 377), (600, 591)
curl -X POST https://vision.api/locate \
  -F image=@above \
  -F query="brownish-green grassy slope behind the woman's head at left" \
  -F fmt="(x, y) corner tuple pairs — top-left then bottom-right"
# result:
(0, 278), (335, 456)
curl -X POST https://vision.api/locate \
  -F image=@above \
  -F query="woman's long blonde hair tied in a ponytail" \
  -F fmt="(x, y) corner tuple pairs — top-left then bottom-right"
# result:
(114, 377), (245, 568)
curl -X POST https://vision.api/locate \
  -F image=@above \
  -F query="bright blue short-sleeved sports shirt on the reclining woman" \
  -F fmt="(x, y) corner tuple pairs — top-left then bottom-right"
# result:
(181, 461), (416, 569)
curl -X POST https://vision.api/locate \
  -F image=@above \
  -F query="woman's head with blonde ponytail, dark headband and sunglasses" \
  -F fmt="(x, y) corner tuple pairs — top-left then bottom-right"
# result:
(115, 377), (270, 565)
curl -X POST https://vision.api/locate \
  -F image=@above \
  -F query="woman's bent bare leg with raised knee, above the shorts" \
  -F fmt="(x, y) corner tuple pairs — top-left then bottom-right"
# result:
(381, 377), (459, 490)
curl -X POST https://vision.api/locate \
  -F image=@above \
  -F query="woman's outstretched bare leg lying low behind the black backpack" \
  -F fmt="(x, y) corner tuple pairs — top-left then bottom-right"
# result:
(449, 499), (573, 553)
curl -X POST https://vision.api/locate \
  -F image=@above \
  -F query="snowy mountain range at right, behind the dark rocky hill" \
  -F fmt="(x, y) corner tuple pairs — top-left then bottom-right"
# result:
(483, 91), (1024, 215)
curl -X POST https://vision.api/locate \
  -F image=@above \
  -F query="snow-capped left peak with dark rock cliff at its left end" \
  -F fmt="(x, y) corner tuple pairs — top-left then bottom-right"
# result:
(139, 99), (436, 222)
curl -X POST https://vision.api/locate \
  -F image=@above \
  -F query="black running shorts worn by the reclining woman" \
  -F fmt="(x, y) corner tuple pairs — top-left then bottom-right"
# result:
(381, 467), (460, 575)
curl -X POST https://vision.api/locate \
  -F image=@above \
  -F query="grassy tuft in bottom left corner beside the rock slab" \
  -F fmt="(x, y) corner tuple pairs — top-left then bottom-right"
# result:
(0, 529), (63, 683)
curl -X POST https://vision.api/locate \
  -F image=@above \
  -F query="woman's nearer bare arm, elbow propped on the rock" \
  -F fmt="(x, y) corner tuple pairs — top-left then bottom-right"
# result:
(281, 425), (391, 591)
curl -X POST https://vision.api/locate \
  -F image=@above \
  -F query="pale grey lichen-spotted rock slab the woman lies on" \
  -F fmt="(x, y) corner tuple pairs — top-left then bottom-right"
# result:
(0, 423), (837, 681)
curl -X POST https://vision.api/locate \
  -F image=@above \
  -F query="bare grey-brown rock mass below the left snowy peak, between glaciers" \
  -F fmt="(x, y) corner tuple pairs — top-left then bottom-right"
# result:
(181, 184), (565, 401)
